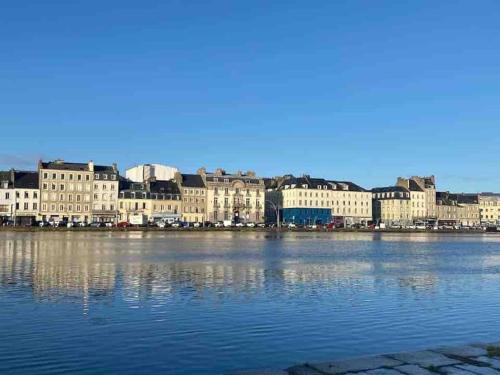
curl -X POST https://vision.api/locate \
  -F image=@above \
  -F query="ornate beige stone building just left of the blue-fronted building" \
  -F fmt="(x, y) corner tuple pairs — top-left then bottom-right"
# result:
(198, 168), (265, 223)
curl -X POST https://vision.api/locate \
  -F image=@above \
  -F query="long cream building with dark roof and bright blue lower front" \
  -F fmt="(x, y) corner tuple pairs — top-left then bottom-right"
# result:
(266, 175), (372, 225)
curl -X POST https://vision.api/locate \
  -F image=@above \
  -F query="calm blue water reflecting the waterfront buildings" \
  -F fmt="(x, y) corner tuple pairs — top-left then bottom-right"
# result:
(0, 232), (500, 374)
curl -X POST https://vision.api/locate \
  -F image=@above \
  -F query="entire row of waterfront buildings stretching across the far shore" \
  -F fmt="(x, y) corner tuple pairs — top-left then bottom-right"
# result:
(0, 159), (500, 226)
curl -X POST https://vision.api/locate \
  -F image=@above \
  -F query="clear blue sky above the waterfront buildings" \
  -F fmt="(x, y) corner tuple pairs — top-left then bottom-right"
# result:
(0, 0), (500, 191)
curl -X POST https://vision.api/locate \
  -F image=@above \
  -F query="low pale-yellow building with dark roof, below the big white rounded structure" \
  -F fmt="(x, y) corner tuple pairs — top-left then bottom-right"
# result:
(118, 179), (182, 222)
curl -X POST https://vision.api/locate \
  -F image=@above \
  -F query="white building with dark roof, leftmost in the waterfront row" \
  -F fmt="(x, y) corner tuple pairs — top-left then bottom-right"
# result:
(0, 169), (40, 225)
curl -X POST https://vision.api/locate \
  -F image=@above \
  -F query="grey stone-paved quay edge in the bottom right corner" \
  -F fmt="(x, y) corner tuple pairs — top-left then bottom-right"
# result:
(230, 343), (500, 375)
